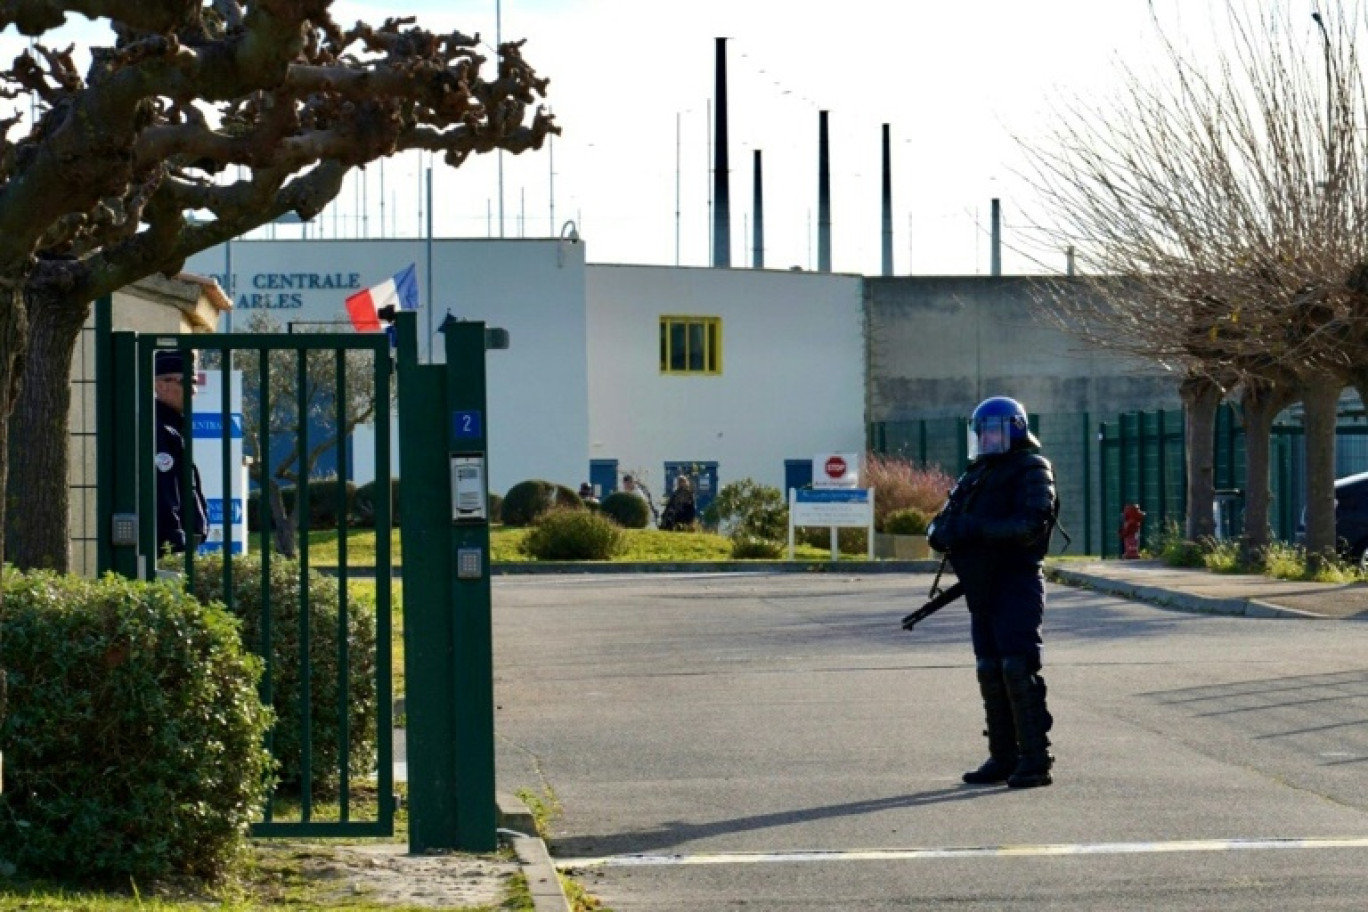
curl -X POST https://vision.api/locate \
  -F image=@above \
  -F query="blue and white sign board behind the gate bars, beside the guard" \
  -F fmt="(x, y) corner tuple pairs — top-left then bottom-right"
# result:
(192, 371), (248, 554)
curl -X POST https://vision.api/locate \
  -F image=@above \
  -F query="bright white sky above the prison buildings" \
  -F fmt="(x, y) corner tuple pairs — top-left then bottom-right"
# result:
(0, 0), (1335, 275)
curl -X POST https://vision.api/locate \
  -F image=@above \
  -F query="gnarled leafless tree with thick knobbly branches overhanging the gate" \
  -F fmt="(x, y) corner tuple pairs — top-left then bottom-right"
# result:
(0, 0), (558, 569)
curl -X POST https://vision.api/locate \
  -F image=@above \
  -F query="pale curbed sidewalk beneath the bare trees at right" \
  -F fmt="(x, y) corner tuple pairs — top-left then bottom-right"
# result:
(1045, 561), (1368, 619)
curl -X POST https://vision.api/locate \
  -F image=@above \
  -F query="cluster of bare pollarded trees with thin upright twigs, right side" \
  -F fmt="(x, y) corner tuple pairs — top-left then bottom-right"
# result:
(1029, 0), (1368, 566)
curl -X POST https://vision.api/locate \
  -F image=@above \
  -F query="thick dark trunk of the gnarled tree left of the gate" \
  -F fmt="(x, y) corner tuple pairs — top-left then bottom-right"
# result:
(7, 298), (90, 573)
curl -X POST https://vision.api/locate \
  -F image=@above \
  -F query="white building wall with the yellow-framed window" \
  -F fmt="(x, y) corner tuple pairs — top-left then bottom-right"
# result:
(587, 265), (865, 494)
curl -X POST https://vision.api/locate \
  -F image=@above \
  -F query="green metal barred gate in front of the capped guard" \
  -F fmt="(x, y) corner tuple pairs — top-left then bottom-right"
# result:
(96, 301), (394, 837)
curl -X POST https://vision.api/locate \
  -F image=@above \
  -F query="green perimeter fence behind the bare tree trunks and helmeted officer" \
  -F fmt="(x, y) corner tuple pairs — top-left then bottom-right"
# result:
(870, 403), (1368, 556)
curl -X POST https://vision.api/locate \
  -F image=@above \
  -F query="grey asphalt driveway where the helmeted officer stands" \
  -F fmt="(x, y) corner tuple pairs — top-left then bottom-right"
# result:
(494, 574), (1368, 912)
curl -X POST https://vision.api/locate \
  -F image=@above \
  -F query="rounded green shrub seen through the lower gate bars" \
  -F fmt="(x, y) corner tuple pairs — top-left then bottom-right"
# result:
(194, 554), (376, 796)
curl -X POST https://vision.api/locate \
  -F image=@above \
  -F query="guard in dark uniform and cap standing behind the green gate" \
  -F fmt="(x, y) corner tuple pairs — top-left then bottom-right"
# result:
(153, 350), (209, 555)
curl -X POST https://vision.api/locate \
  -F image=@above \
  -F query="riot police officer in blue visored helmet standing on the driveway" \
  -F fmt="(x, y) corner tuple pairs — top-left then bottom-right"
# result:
(928, 397), (1059, 789)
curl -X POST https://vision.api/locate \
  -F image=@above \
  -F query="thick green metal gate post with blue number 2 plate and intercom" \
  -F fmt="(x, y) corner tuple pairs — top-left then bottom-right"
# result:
(395, 312), (498, 852)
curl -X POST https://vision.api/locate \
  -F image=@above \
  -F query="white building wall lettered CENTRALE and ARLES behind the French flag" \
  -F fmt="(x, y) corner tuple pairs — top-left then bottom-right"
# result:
(186, 238), (590, 492)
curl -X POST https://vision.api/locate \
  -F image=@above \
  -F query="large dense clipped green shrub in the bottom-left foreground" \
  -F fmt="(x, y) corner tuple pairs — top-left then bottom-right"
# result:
(0, 570), (271, 883)
